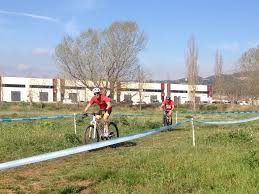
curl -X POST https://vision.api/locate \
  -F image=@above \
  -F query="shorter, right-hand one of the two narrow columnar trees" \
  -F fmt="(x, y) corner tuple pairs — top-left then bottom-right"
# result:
(214, 50), (224, 100)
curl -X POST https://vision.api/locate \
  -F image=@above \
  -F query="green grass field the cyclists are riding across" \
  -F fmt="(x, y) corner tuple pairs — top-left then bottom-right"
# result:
(0, 102), (259, 194)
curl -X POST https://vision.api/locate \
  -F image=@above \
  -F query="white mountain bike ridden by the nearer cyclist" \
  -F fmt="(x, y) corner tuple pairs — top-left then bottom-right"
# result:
(83, 113), (119, 144)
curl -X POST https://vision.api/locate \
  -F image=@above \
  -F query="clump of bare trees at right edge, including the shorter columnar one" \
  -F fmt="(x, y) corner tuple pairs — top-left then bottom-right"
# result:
(214, 47), (259, 100)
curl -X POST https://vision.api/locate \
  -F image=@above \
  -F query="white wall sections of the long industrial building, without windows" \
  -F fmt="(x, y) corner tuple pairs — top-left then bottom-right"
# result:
(2, 77), (209, 103)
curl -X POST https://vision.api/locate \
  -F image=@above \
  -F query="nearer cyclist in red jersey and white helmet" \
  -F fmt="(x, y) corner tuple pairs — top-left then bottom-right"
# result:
(84, 88), (112, 129)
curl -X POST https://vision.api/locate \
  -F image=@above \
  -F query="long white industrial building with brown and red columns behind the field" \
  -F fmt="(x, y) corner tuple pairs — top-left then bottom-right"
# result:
(0, 77), (212, 104)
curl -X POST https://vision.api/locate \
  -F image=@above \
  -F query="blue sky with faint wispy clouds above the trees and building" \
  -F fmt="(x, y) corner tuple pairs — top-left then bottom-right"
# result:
(0, 0), (259, 79)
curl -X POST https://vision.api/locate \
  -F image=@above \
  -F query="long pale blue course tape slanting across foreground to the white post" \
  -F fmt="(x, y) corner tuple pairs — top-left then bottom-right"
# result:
(0, 120), (190, 170)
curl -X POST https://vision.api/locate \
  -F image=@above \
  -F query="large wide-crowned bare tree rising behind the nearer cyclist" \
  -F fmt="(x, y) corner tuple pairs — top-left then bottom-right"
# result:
(56, 22), (146, 97)
